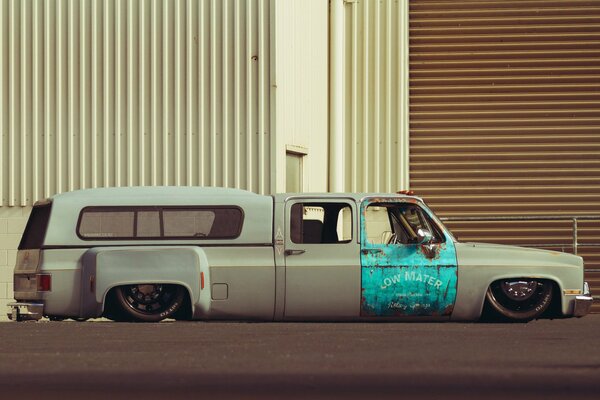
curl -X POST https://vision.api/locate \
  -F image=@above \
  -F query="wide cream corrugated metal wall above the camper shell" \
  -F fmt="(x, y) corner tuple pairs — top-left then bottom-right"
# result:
(0, 0), (271, 206)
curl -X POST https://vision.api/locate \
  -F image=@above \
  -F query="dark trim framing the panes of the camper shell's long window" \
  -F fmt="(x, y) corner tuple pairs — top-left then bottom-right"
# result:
(75, 205), (246, 242)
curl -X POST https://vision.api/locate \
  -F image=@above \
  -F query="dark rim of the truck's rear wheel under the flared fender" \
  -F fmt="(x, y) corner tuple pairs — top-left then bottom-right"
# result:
(121, 284), (177, 315)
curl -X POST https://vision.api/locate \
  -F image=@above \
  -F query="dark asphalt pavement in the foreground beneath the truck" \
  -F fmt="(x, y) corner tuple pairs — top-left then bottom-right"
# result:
(0, 315), (600, 400)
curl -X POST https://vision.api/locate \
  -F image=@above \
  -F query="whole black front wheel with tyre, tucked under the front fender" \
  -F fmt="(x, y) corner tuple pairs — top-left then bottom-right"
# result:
(486, 278), (552, 321)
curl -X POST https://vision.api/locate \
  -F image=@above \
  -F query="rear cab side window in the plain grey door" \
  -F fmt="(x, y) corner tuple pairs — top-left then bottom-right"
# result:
(290, 203), (352, 244)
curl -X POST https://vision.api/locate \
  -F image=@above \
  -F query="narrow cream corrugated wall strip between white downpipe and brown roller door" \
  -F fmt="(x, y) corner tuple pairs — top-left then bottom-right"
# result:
(344, 0), (409, 192)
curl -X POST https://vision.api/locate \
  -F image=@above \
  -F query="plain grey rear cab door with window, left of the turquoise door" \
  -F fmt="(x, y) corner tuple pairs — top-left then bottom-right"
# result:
(284, 199), (360, 319)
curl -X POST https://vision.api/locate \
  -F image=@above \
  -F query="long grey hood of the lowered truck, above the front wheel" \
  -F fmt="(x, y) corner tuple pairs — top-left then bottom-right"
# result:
(455, 243), (583, 268)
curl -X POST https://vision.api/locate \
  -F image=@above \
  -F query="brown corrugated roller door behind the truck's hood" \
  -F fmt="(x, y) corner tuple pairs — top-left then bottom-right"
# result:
(410, 0), (600, 311)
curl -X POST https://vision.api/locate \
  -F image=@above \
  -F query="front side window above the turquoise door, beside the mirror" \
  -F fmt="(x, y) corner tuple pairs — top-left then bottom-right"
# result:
(365, 203), (445, 244)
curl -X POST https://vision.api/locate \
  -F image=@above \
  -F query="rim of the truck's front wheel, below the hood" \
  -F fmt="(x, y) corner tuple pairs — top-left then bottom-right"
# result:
(490, 279), (551, 313)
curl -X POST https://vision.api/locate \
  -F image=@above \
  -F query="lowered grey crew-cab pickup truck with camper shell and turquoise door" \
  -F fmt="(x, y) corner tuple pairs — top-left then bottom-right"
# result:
(8, 187), (592, 321)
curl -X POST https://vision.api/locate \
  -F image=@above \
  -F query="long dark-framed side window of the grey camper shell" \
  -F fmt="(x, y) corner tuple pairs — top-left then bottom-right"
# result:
(77, 206), (244, 240)
